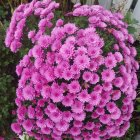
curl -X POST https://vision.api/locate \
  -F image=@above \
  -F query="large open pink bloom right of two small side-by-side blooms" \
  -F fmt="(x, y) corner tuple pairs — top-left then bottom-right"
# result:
(101, 69), (115, 82)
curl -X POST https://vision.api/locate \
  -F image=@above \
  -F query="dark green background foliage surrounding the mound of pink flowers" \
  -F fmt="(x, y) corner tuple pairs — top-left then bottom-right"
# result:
(0, 0), (140, 140)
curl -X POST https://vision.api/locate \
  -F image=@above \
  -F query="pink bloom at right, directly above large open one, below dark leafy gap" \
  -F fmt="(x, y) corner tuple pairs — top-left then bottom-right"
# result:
(105, 55), (117, 68)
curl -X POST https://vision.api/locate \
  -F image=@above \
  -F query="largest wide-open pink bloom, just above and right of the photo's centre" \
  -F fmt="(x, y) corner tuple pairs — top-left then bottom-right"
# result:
(74, 55), (90, 70)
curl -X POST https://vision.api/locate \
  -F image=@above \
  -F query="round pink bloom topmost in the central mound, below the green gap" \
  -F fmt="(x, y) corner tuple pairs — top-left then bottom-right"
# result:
(64, 23), (77, 34)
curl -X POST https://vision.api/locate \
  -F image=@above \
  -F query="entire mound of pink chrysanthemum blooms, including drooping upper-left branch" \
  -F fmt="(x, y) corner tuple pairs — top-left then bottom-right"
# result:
(5, 0), (139, 140)
